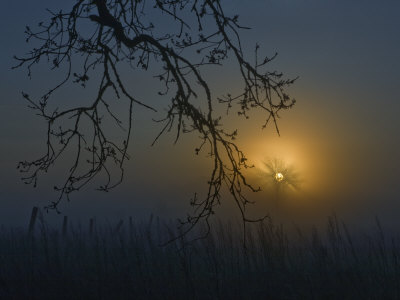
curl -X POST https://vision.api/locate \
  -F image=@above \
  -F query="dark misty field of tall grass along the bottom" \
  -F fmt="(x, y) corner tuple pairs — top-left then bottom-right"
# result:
(0, 212), (400, 299)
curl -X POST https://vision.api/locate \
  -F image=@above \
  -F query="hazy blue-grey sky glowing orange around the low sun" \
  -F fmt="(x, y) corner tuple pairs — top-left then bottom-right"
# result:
(0, 0), (400, 229)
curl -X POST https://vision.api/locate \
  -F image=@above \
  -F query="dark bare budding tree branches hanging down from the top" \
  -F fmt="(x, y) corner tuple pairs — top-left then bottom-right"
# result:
(15, 0), (296, 239)
